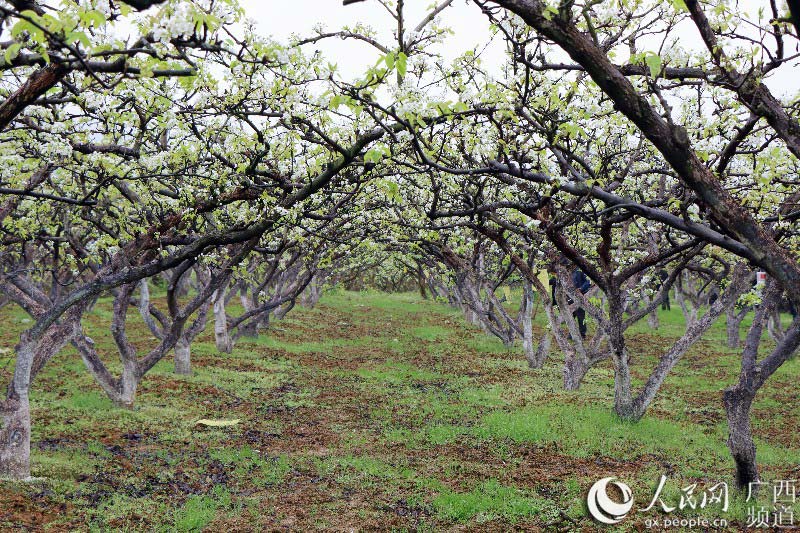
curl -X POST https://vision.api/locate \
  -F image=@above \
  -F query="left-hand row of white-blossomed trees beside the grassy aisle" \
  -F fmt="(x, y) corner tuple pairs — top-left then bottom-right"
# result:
(0, 0), (410, 478)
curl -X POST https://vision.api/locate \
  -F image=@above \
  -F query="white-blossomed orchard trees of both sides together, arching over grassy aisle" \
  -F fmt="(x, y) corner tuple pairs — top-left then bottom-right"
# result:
(0, 0), (800, 494)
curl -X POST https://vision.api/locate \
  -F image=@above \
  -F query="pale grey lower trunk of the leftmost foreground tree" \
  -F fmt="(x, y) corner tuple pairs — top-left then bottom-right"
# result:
(0, 391), (31, 480)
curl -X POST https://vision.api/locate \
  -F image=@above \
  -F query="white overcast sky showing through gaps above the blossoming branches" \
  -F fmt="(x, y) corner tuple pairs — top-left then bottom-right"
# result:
(240, 0), (800, 97)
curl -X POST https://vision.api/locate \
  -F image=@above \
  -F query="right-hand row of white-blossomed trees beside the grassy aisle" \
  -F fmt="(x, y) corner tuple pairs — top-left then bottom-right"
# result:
(340, 0), (800, 487)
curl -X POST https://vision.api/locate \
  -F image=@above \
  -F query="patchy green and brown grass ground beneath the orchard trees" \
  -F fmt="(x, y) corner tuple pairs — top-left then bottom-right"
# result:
(0, 293), (800, 531)
